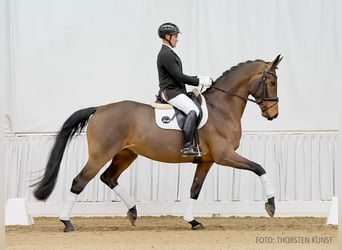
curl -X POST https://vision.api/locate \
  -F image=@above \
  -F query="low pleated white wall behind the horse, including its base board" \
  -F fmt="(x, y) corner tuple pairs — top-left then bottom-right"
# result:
(5, 131), (337, 216)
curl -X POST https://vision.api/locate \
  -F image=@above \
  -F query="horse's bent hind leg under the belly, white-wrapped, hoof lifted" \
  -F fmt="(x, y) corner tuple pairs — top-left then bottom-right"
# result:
(100, 149), (137, 226)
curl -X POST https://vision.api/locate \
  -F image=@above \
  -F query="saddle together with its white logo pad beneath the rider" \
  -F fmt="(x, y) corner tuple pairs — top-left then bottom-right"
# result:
(151, 89), (208, 130)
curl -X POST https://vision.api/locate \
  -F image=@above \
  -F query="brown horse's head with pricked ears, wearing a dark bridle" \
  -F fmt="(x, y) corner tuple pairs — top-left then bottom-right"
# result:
(249, 55), (283, 120)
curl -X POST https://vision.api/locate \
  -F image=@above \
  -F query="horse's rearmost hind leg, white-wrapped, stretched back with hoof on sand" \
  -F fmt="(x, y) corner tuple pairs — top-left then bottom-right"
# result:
(59, 157), (108, 232)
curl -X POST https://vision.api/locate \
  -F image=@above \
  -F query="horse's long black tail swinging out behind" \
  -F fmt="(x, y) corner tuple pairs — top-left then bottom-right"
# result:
(32, 108), (96, 201)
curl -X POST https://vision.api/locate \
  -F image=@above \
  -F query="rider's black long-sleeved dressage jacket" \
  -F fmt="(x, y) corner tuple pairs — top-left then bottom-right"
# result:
(157, 45), (199, 100)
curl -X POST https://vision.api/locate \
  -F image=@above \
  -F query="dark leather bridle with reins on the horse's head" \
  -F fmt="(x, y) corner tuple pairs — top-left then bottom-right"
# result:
(211, 65), (279, 105)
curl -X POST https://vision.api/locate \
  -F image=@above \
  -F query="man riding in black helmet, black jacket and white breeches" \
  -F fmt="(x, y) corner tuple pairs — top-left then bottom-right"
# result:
(157, 23), (212, 156)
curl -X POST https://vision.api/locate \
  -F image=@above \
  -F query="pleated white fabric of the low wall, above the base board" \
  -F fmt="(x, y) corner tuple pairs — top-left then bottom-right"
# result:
(5, 131), (337, 206)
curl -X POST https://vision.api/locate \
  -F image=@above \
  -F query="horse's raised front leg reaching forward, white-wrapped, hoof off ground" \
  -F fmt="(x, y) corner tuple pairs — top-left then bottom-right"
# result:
(214, 151), (275, 217)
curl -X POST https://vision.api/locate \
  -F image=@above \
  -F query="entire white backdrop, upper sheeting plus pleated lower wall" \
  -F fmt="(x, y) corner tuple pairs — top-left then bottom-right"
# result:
(2, 0), (342, 216)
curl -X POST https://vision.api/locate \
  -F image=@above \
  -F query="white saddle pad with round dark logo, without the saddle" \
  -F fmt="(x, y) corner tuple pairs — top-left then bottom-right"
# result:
(154, 95), (208, 130)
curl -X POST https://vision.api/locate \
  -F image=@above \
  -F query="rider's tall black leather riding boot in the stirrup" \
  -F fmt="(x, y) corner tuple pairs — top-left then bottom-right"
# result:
(181, 110), (201, 157)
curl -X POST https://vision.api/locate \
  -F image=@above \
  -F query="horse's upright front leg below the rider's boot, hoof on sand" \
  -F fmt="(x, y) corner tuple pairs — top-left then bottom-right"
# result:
(184, 162), (213, 230)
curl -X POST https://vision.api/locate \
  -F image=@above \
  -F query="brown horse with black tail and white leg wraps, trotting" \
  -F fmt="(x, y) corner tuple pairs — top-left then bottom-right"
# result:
(33, 55), (283, 232)
